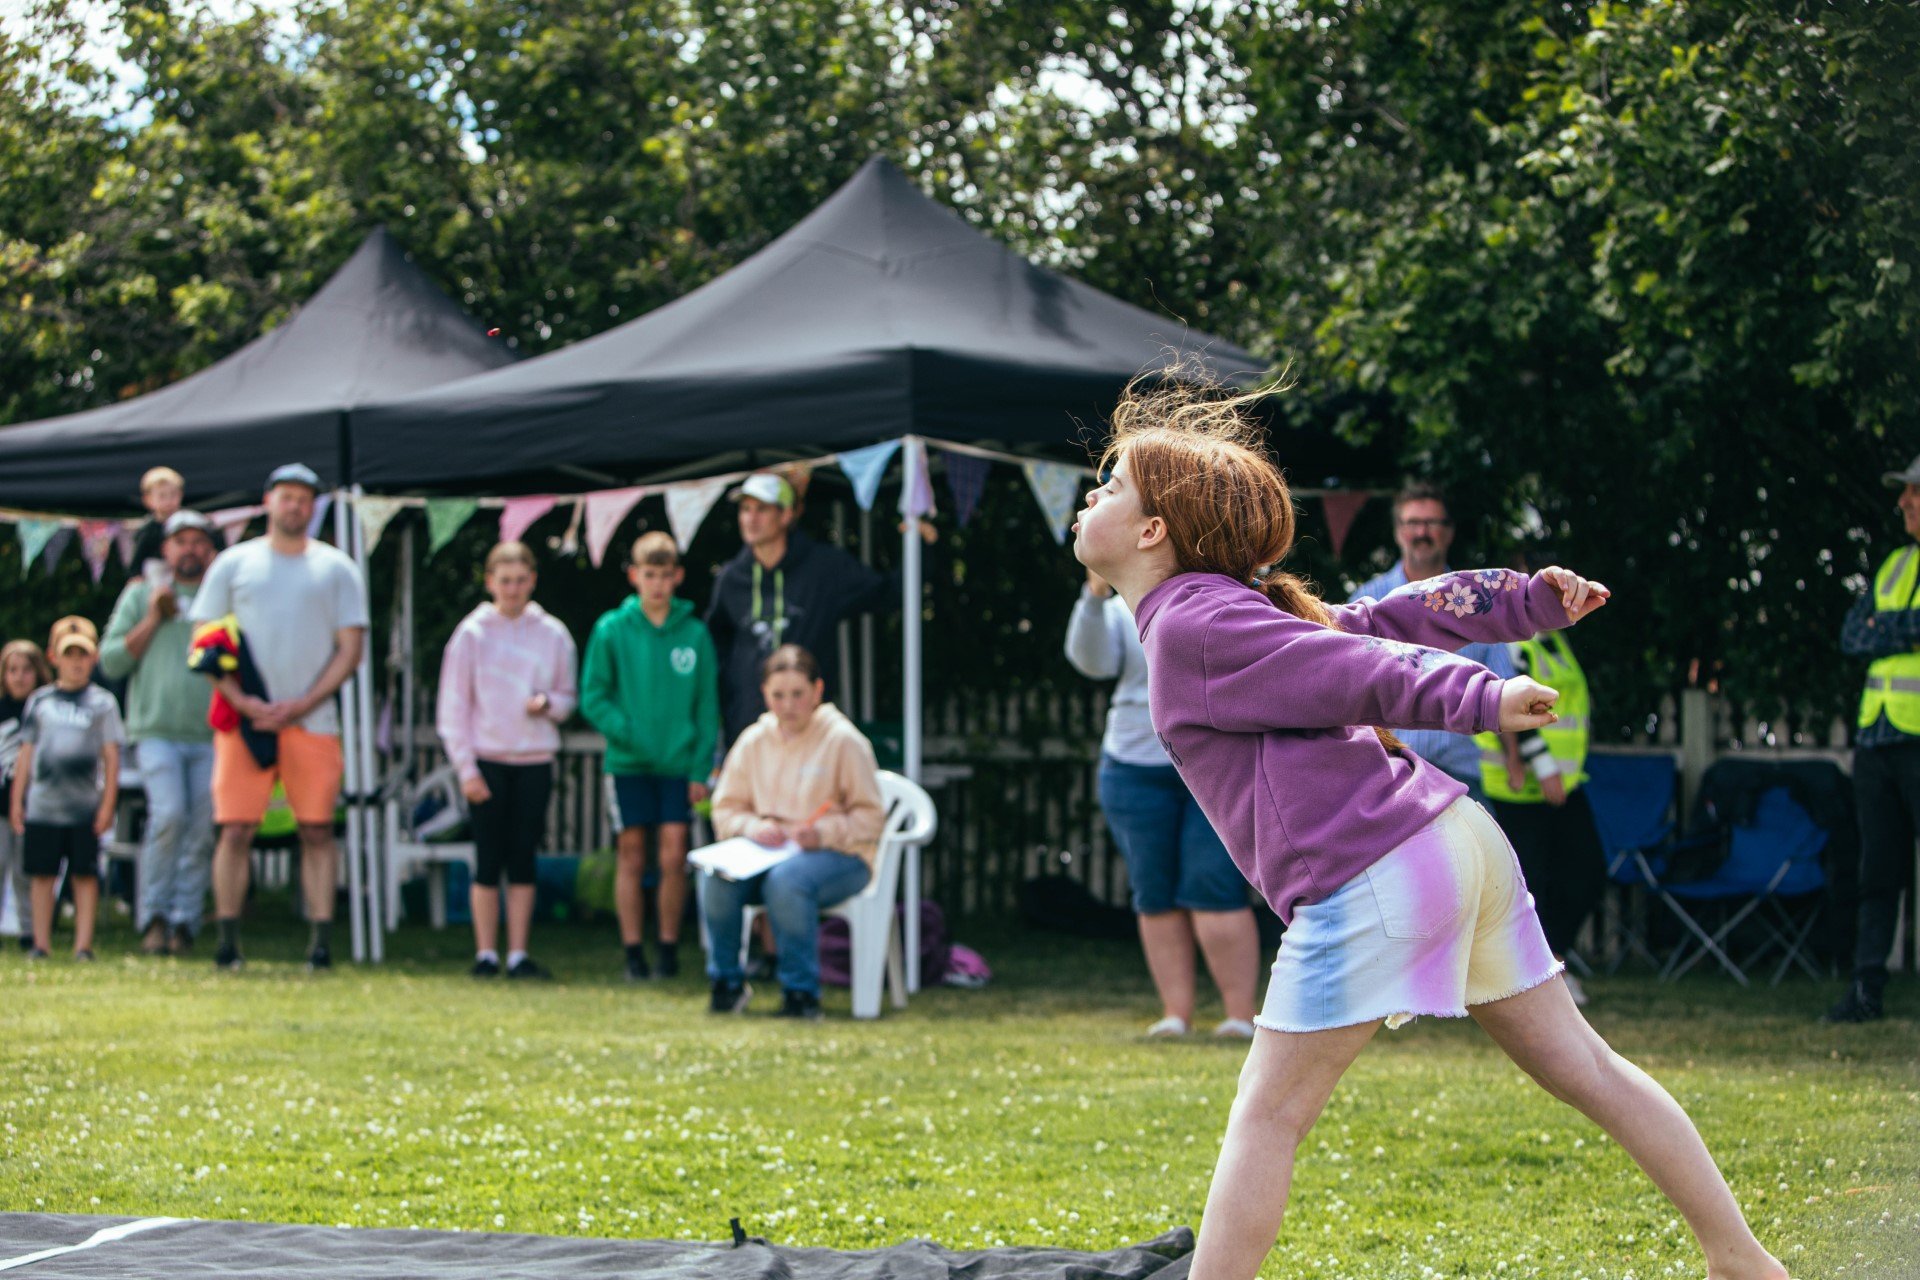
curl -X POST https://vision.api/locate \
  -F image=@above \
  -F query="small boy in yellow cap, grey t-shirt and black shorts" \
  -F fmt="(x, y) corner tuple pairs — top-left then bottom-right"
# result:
(8, 618), (125, 960)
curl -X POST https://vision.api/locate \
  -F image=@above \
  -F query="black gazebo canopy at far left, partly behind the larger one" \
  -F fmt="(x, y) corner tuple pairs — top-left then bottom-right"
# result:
(0, 228), (513, 512)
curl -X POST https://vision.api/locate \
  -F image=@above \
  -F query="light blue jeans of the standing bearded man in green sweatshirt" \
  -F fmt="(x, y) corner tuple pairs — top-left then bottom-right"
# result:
(134, 737), (213, 933)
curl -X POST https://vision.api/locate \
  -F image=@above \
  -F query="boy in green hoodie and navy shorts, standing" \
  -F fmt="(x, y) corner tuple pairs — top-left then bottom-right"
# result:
(580, 532), (720, 983)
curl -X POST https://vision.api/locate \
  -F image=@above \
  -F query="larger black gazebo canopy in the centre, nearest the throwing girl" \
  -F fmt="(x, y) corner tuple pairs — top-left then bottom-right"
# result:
(353, 159), (1261, 491)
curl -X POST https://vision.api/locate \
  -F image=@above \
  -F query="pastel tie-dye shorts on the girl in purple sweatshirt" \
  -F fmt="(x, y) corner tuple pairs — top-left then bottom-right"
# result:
(1254, 796), (1563, 1031)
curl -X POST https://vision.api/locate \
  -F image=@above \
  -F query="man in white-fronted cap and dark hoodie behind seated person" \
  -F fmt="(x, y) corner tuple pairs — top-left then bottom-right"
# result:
(707, 472), (933, 745)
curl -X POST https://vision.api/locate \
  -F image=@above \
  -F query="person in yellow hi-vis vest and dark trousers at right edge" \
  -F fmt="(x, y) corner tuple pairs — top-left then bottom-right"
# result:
(1826, 457), (1920, 1023)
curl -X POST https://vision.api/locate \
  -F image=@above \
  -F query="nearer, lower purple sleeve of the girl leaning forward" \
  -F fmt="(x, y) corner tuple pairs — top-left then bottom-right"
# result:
(1183, 597), (1501, 733)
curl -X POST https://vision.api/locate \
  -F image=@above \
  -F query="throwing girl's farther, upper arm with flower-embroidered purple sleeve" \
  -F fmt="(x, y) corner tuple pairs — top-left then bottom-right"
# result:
(1332, 566), (1611, 656)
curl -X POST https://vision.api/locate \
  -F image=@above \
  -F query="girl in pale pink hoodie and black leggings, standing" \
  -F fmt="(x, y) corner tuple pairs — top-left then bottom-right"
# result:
(434, 543), (580, 979)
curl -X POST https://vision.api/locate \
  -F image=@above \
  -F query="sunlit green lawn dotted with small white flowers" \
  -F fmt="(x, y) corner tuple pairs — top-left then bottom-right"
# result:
(0, 906), (1920, 1280)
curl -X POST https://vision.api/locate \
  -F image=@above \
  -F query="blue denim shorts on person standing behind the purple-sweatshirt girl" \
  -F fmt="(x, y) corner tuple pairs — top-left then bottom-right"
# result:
(1100, 756), (1246, 915)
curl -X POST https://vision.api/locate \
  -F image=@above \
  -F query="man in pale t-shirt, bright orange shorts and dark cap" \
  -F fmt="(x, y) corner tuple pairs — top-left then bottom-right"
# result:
(192, 462), (367, 969)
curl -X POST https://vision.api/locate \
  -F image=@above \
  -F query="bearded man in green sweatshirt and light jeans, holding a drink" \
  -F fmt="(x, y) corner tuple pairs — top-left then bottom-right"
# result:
(100, 510), (215, 956)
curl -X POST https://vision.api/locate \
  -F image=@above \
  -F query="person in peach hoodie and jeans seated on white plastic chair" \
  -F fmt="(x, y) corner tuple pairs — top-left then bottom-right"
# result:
(701, 645), (887, 1019)
